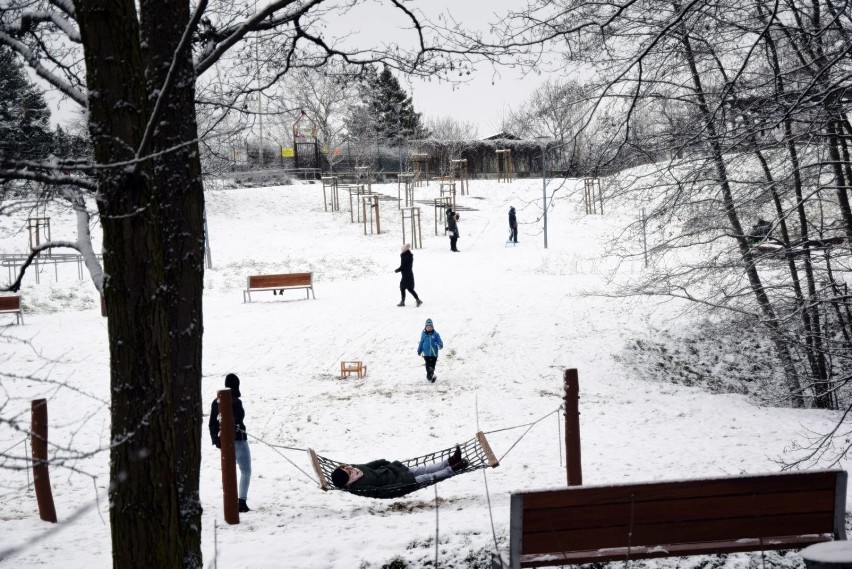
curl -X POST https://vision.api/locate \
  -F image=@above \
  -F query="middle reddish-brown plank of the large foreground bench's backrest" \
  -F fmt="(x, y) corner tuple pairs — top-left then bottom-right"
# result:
(524, 490), (835, 532)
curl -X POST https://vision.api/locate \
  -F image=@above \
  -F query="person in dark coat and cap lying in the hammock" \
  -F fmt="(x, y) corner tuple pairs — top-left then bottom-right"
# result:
(331, 445), (470, 490)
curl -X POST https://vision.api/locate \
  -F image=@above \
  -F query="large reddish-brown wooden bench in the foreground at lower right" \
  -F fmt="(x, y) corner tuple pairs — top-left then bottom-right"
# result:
(510, 470), (846, 569)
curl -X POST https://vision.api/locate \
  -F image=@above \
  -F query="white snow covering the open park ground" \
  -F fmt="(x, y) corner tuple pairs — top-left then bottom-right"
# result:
(0, 175), (839, 569)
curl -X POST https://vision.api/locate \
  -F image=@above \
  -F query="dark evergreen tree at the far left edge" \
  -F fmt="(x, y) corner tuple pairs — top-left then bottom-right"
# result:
(0, 46), (53, 159)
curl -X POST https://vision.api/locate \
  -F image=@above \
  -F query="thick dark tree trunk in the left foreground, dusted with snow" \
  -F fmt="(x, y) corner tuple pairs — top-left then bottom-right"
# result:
(75, 0), (203, 567)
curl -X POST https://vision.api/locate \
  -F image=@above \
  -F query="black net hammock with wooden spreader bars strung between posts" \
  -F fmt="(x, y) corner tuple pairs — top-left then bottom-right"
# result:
(308, 432), (500, 499)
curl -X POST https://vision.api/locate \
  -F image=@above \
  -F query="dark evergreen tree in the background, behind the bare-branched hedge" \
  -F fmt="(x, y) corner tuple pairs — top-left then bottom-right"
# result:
(346, 66), (429, 140)
